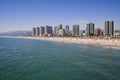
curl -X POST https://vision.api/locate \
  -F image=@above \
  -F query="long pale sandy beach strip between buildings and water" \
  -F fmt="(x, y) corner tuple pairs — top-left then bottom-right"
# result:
(0, 36), (120, 49)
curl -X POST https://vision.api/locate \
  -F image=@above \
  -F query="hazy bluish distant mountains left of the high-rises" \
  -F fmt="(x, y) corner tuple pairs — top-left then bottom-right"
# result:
(0, 31), (32, 36)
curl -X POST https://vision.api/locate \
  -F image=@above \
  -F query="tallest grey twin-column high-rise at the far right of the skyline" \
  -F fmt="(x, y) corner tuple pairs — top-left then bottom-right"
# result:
(104, 21), (114, 36)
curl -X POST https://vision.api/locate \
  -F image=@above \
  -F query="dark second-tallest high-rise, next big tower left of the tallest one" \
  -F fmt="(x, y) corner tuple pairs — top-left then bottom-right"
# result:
(86, 23), (95, 36)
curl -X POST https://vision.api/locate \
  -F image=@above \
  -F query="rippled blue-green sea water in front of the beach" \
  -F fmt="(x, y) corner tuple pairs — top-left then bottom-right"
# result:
(0, 38), (120, 80)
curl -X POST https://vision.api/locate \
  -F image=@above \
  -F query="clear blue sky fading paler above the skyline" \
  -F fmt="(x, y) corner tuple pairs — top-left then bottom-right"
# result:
(0, 0), (120, 32)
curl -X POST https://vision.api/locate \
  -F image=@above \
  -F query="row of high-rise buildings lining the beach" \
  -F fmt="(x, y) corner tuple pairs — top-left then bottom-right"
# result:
(32, 21), (114, 37)
